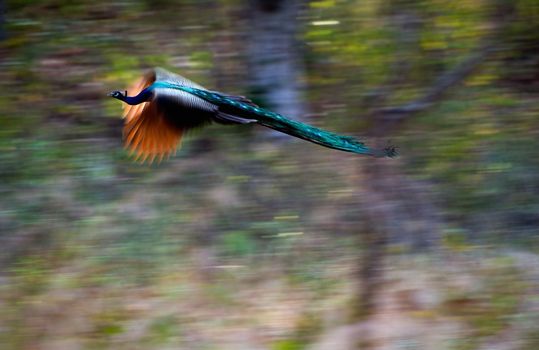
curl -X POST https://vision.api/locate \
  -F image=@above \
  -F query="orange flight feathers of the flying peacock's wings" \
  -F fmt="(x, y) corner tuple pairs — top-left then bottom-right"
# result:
(123, 72), (183, 163)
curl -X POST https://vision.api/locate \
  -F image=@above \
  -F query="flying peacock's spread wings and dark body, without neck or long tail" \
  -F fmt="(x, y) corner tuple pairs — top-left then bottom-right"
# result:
(119, 68), (262, 162)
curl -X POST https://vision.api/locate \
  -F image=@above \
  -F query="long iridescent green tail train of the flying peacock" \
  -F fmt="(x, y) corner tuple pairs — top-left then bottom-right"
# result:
(177, 86), (396, 157)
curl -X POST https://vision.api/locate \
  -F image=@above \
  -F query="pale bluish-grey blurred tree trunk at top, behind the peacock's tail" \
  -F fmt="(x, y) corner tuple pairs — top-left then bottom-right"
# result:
(247, 0), (306, 119)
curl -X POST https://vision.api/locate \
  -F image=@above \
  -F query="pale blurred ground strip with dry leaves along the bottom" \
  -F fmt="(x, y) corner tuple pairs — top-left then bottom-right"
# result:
(2, 245), (539, 349)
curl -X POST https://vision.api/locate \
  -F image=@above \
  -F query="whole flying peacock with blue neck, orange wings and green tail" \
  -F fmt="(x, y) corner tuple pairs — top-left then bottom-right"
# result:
(109, 68), (396, 162)
